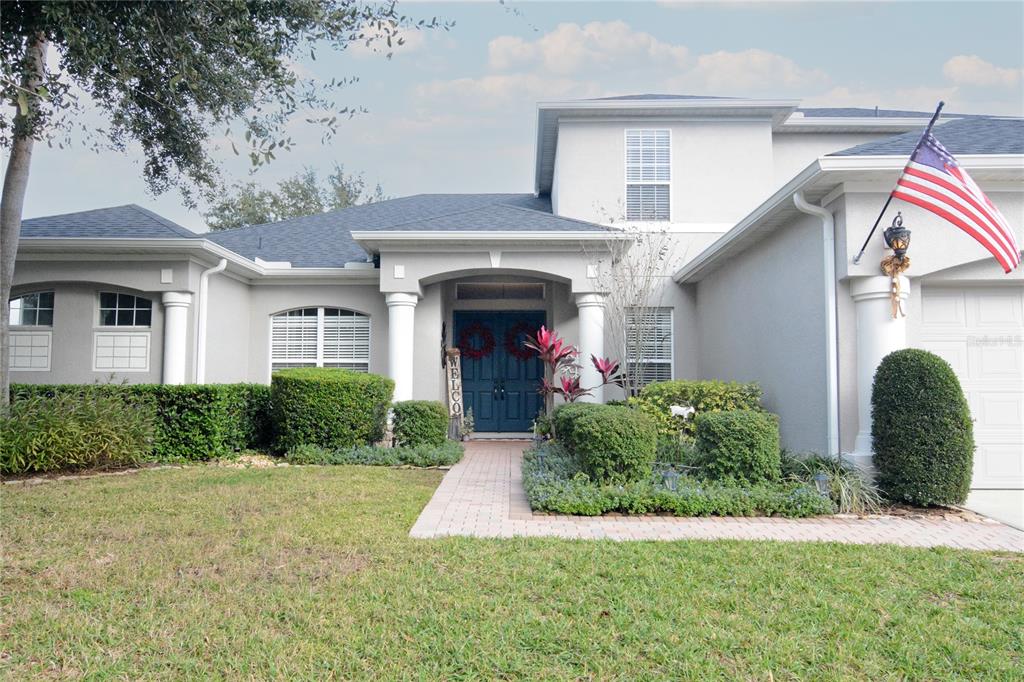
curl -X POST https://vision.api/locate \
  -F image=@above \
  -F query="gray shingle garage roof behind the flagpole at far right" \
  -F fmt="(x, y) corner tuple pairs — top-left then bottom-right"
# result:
(828, 118), (1024, 157)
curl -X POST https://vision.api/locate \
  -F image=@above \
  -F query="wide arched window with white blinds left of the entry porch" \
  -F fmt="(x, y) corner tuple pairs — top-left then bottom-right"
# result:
(270, 308), (370, 372)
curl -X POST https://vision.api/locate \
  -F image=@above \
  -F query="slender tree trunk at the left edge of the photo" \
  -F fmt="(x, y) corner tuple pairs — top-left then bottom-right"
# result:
(0, 35), (46, 407)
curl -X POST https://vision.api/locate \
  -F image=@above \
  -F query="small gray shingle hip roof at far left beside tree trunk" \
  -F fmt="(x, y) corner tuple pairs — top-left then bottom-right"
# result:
(22, 204), (200, 239)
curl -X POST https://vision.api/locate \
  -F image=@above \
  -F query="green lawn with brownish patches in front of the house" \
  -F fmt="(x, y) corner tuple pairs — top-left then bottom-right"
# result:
(0, 467), (1024, 680)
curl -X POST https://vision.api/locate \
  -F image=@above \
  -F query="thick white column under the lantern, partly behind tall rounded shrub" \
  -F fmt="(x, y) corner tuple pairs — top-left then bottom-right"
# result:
(850, 275), (910, 469)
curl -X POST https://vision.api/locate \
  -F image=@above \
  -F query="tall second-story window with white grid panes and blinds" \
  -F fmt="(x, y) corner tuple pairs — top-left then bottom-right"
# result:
(626, 129), (672, 220)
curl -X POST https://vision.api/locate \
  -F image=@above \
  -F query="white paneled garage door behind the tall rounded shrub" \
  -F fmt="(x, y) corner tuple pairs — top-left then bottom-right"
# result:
(921, 287), (1024, 488)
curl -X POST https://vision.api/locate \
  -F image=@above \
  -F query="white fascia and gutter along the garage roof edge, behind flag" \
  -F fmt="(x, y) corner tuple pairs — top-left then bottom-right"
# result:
(672, 154), (1024, 284)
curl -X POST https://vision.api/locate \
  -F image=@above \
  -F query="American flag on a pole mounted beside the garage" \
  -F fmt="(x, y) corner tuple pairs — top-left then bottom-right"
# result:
(893, 130), (1021, 272)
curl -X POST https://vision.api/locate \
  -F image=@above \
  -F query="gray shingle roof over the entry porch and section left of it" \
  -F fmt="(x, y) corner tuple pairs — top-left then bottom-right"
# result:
(207, 195), (604, 267)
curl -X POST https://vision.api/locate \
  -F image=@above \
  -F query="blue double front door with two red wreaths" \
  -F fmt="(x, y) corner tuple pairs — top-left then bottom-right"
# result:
(453, 310), (545, 432)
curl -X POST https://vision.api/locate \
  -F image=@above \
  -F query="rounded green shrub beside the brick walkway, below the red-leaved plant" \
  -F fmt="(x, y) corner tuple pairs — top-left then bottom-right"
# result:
(563, 404), (657, 483)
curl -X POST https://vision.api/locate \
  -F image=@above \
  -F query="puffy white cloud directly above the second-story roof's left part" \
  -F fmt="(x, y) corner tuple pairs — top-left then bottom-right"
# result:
(487, 22), (689, 75)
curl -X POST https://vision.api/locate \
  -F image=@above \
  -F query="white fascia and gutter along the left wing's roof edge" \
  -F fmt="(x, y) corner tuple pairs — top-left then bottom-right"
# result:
(18, 237), (380, 280)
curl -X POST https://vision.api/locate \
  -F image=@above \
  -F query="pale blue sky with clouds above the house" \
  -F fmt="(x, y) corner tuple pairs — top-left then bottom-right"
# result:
(14, 0), (1024, 231)
